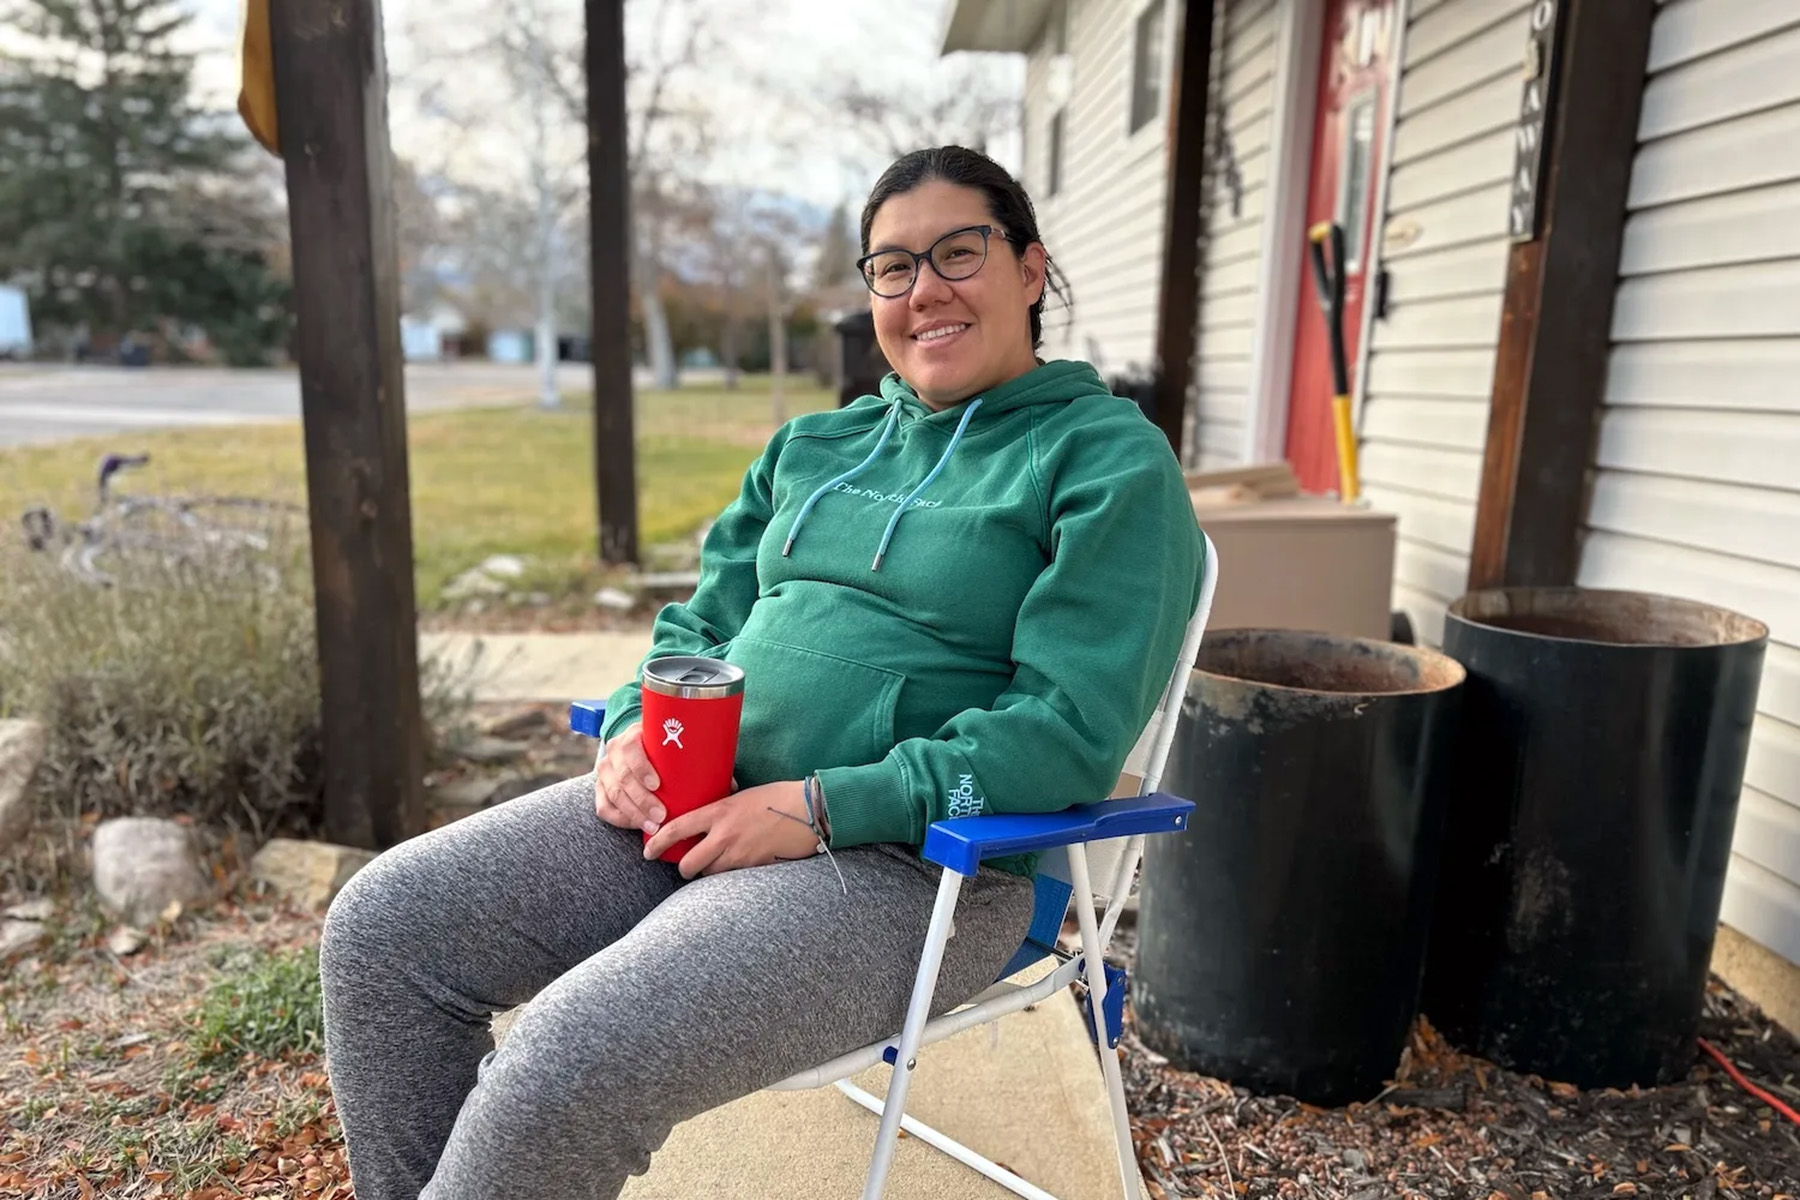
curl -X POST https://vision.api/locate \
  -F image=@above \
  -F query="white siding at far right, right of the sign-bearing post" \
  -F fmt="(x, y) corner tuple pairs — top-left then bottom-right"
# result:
(1579, 0), (1800, 963)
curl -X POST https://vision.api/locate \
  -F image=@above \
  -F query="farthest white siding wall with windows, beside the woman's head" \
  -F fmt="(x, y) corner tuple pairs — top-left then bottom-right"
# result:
(1024, 0), (1168, 378)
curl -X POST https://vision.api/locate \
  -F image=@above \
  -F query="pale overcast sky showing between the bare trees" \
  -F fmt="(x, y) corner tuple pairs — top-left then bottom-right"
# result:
(185, 0), (1024, 207)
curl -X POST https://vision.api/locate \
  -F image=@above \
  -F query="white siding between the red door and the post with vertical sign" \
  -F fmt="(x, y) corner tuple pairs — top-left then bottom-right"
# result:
(1359, 0), (1528, 644)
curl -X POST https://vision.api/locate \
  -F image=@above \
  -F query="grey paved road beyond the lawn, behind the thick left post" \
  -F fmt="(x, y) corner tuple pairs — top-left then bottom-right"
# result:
(0, 363), (608, 446)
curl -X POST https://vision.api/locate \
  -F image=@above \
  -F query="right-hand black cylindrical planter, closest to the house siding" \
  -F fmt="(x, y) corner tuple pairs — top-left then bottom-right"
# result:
(1422, 588), (1768, 1087)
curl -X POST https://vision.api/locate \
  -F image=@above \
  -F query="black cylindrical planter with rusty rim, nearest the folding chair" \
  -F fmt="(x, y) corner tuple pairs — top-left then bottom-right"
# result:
(1132, 630), (1463, 1105)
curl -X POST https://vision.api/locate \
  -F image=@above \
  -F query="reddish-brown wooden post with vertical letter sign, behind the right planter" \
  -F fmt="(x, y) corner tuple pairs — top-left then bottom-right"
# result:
(1469, 0), (1656, 588)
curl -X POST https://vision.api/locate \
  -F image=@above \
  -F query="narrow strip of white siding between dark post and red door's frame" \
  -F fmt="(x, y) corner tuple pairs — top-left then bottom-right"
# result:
(1188, 0), (1282, 470)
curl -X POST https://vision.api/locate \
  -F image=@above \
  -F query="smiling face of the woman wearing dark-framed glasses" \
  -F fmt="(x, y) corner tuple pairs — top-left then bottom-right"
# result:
(868, 180), (1044, 408)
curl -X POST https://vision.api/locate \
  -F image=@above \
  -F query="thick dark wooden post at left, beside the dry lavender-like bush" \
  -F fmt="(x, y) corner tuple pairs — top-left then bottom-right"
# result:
(270, 0), (425, 849)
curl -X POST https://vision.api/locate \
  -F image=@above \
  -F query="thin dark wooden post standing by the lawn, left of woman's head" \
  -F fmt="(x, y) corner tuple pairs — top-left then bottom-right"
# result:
(587, 0), (639, 565)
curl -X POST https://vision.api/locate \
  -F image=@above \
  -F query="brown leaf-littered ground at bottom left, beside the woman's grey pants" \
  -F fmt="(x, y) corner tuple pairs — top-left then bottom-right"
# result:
(0, 905), (353, 1200)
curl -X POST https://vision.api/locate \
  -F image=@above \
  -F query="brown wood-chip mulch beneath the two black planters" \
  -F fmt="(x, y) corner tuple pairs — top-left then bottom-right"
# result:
(1114, 928), (1800, 1200)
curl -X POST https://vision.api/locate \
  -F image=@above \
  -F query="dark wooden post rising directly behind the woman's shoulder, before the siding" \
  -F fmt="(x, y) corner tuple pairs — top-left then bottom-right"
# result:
(1152, 0), (1213, 455)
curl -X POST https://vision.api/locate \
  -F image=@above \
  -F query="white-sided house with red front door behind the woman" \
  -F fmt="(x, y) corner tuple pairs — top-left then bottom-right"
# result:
(943, 0), (1800, 1021)
